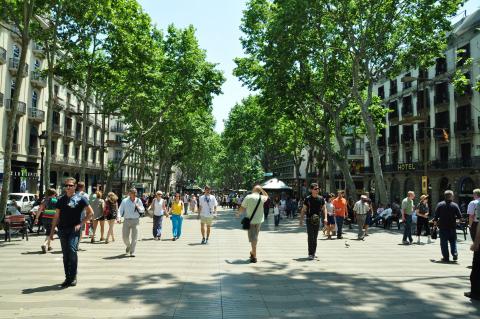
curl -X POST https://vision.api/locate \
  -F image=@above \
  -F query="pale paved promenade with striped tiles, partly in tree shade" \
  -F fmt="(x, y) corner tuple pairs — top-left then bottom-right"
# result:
(0, 210), (480, 319)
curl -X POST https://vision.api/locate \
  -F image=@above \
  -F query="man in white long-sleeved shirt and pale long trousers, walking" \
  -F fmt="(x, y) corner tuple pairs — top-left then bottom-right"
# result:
(118, 188), (145, 257)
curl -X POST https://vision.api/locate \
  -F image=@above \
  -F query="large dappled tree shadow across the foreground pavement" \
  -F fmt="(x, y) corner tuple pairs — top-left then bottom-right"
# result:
(85, 261), (480, 319)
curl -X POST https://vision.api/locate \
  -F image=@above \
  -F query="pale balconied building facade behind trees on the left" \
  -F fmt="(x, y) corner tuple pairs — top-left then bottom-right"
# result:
(0, 28), (108, 193)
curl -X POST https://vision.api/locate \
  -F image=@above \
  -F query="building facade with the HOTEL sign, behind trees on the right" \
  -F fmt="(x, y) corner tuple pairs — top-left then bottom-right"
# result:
(364, 10), (480, 205)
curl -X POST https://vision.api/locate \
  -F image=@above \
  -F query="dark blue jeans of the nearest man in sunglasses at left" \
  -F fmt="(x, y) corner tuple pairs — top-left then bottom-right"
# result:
(58, 229), (80, 281)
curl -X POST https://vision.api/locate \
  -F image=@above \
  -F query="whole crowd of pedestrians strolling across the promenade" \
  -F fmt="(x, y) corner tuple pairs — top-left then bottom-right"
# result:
(22, 178), (480, 299)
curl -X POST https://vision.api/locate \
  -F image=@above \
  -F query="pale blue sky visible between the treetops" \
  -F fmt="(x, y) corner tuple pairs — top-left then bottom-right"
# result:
(139, 0), (480, 132)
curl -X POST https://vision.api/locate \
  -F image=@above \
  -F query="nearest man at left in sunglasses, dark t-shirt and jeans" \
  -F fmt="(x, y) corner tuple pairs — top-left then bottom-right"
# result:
(50, 177), (93, 288)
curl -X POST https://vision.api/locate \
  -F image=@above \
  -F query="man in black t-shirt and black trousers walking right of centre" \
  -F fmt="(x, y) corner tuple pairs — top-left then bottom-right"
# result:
(300, 183), (327, 260)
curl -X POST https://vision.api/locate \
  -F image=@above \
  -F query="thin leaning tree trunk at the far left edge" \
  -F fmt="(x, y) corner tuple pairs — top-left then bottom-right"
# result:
(0, 0), (35, 220)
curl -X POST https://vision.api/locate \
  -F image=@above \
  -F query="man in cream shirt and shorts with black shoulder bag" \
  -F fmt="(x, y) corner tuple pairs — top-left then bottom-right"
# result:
(237, 185), (268, 263)
